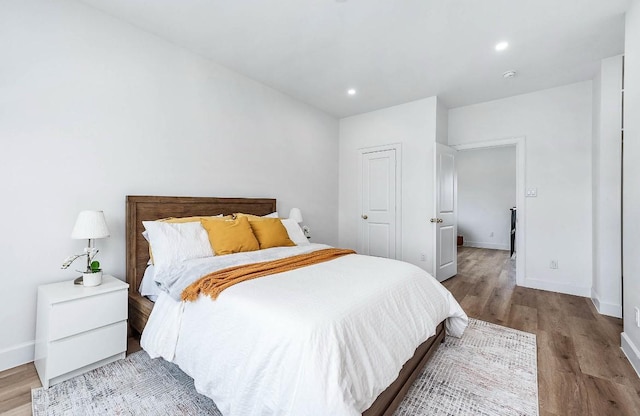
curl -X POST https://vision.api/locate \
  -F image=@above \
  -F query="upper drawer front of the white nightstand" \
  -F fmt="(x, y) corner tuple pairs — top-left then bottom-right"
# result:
(49, 290), (127, 341)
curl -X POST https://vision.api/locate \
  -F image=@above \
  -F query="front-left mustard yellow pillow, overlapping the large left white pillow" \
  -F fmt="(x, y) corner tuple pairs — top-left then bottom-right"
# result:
(200, 217), (260, 255)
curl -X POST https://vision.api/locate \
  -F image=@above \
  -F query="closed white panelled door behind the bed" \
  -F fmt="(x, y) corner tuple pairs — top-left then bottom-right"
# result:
(358, 149), (397, 259)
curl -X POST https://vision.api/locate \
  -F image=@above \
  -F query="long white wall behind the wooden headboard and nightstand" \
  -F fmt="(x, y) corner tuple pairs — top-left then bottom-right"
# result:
(0, 0), (338, 370)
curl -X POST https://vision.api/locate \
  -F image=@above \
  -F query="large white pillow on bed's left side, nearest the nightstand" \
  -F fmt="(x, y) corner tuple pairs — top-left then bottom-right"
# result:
(142, 221), (213, 273)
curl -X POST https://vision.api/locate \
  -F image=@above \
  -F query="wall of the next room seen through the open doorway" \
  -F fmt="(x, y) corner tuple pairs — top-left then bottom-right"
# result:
(456, 146), (516, 250)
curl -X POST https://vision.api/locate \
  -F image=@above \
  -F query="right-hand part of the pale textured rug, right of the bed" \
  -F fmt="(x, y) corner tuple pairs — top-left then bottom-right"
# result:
(394, 319), (538, 416)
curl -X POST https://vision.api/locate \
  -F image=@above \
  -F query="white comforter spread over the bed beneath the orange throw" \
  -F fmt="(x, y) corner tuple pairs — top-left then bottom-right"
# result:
(141, 245), (468, 416)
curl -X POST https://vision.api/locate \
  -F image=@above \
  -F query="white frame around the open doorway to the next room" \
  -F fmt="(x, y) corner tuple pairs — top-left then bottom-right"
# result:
(449, 136), (527, 286)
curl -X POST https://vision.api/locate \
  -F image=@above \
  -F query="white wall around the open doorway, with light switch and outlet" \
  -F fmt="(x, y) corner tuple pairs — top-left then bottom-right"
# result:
(449, 81), (592, 296)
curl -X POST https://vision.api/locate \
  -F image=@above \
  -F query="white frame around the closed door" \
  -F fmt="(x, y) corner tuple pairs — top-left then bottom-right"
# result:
(357, 143), (402, 260)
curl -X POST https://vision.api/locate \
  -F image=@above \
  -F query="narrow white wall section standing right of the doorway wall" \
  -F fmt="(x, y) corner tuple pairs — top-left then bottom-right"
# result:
(591, 55), (622, 318)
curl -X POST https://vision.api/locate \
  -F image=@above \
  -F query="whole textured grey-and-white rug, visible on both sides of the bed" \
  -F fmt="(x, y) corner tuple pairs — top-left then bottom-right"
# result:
(31, 319), (538, 416)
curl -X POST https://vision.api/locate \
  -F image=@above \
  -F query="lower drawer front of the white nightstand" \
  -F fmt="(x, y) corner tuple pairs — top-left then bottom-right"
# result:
(47, 321), (127, 378)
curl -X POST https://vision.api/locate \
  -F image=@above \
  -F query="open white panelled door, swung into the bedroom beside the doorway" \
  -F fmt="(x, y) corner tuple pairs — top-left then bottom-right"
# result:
(431, 143), (458, 282)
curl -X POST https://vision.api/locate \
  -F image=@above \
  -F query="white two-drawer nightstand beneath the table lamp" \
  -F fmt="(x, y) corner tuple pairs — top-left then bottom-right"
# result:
(35, 275), (129, 388)
